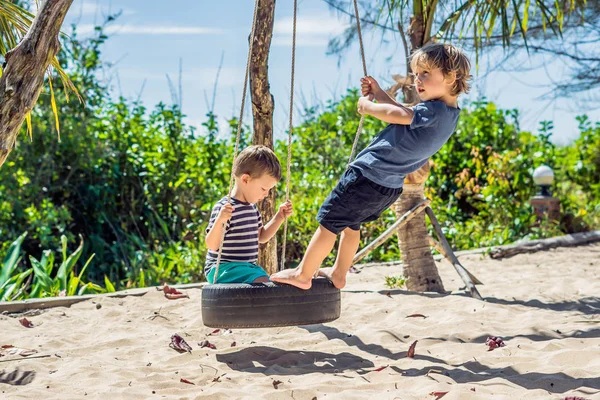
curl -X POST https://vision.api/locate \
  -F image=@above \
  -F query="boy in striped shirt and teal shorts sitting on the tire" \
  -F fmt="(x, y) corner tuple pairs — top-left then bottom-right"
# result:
(204, 146), (293, 283)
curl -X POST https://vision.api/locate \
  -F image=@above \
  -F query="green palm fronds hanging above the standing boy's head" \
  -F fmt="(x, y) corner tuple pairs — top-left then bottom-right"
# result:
(324, 0), (587, 61)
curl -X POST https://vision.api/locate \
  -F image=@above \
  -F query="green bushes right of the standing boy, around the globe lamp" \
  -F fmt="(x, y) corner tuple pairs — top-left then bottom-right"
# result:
(427, 102), (600, 249)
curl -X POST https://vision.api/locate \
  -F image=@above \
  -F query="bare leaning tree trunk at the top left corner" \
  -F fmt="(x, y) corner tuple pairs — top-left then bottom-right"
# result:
(0, 0), (73, 166)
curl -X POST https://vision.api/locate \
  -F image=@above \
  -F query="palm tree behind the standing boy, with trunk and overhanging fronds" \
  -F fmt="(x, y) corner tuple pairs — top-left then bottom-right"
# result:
(324, 0), (586, 292)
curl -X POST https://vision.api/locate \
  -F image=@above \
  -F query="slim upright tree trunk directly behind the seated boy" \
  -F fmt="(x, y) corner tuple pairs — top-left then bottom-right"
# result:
(250, 0), (277, 274)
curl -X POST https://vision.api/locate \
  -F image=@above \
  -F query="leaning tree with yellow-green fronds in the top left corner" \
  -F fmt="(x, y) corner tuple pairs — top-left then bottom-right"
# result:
(0, 0), (81, 166)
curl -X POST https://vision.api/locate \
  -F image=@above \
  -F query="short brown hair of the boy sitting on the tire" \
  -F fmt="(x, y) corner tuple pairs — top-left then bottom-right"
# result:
(233, 145), (281, 180)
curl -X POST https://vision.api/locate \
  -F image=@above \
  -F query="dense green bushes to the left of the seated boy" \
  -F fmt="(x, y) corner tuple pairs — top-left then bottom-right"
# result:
(0, 29), (243, 293)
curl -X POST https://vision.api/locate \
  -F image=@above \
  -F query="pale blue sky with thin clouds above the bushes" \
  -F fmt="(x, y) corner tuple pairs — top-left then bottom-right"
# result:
(65, 0), (600, 143)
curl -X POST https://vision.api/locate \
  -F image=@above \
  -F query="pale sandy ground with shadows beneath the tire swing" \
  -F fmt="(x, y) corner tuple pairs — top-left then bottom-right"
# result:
(0, 245), (600, 400)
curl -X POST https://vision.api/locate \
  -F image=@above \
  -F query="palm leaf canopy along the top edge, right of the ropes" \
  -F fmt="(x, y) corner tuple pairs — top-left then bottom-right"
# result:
(326, 0), (584, 74)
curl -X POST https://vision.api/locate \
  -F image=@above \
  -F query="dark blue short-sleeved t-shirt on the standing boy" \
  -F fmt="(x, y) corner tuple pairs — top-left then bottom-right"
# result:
(350, 100), (460, 189)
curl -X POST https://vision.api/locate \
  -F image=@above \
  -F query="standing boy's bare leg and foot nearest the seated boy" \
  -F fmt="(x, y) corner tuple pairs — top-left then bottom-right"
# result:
(271, 225), (337, 289)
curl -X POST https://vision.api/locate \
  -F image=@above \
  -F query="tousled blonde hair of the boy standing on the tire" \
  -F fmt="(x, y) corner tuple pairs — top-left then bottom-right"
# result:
(410, 43), (472, 96)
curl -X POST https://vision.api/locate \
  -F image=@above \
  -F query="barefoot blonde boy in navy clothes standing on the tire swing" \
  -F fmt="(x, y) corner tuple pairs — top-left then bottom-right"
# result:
(271, 43), (471, 289)
